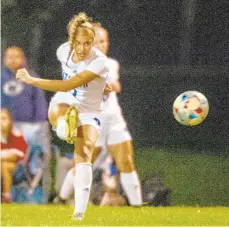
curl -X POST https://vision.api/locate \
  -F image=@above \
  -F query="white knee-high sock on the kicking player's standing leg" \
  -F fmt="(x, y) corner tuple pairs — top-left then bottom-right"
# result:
(74, 163), (92, 214)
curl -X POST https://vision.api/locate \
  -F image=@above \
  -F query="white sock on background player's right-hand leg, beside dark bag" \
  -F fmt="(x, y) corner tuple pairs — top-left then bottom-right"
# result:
(120, 171), (142, 206)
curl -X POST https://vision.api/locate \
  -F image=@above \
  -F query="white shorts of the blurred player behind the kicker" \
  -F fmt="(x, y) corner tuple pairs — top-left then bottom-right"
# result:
(96, 115), (132, 147)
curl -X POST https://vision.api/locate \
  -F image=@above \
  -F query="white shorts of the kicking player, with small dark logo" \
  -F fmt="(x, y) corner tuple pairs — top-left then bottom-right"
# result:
(49, 92), (101, 133)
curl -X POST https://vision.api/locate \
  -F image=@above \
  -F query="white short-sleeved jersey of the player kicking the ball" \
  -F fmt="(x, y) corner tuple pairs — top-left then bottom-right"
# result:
(57, 43), (108, 113)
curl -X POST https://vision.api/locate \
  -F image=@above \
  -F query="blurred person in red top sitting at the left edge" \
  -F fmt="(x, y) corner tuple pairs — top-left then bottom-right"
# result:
(0, 109), (27, 203)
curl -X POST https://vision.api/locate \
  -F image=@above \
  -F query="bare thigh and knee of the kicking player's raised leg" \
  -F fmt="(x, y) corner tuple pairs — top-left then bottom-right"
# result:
(48, 103), (69, 128)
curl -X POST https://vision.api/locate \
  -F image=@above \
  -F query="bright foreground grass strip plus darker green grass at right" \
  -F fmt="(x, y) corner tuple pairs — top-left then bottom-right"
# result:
(1, 149), (229, 226)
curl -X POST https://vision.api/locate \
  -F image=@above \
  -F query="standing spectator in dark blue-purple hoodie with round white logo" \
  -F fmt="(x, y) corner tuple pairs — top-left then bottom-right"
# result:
(1, 46), (51, 202)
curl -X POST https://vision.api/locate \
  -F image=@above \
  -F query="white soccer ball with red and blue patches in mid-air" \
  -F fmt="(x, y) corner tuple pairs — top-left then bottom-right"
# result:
(173, 91), (209, 126)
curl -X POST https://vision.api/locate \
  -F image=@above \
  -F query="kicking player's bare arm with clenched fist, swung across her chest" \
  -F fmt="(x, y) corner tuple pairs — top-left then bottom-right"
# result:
(16, 69), (99, 92)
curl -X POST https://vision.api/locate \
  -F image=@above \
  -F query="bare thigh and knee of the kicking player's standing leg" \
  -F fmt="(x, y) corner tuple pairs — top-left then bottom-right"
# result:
(74, 125), (99, 164)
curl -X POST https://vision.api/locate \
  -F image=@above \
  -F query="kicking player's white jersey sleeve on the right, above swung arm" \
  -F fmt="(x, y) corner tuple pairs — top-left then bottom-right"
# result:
(85, 56), (108, 78)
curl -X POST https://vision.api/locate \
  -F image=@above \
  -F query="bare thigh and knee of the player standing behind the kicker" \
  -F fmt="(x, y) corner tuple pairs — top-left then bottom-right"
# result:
(108, 140), (134, 173)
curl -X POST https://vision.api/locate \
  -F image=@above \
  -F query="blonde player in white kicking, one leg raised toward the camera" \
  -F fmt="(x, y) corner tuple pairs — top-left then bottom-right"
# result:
(16, 13), (110, 220)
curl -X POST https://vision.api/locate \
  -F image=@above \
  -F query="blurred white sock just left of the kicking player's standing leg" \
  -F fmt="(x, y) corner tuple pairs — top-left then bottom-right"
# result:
(60, 169), (75, 200)
